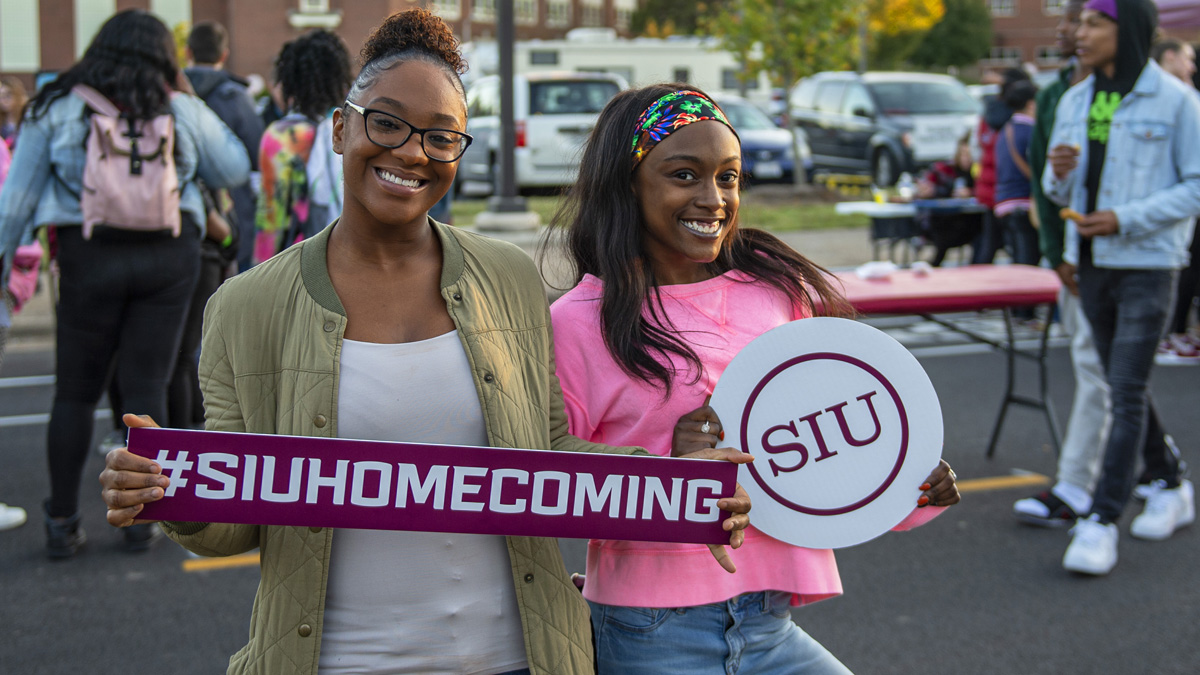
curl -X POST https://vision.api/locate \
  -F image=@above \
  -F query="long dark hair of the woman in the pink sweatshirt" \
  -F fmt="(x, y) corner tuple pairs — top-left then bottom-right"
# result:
(542, 83), (853, 396)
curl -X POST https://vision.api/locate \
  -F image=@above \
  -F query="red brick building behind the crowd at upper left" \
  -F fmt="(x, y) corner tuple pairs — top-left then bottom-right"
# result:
(0, 0), (637, 91)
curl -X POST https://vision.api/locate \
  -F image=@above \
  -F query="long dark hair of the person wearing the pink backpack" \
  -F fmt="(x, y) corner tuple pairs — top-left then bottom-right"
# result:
(30, 10), (179, 120)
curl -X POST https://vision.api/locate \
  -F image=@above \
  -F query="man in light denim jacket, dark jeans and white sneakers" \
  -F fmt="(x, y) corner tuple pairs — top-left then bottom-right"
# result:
(1043, 0), (1200, 575)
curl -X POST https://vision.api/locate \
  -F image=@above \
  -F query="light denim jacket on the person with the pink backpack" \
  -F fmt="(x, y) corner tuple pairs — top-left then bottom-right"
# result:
(0, 88), (250, 282)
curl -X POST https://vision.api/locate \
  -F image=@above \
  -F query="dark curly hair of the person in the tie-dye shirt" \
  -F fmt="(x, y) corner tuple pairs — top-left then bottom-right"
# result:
(275, 30), (352, 119)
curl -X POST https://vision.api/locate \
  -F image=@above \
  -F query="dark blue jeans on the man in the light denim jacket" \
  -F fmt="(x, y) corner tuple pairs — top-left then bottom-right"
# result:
(1079, 263), (1180, 522)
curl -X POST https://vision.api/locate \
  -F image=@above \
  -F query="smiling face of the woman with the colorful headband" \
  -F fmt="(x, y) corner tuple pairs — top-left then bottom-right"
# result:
(634, 121), (742, 285)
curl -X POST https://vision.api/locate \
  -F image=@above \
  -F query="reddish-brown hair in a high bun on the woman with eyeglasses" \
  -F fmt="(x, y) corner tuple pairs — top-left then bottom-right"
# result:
(350, 7), (467, 105)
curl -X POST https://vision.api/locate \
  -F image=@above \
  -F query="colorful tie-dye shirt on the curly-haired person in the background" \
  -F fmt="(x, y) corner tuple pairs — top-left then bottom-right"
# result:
(254, 114), (316, 263)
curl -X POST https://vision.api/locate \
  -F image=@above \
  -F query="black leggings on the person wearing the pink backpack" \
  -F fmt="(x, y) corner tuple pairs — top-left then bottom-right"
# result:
(46, 225), (200, 518)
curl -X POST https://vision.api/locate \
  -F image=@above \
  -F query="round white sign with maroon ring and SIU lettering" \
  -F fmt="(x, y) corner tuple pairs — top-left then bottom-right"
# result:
(709, 317), (942, 549)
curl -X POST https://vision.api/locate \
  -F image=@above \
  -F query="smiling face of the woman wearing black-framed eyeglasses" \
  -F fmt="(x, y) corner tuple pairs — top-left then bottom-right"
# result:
(334, 61), (467, 236)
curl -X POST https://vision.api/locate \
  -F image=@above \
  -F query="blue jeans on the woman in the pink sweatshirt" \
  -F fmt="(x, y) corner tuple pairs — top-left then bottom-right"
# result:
(588, 591), (850, 675)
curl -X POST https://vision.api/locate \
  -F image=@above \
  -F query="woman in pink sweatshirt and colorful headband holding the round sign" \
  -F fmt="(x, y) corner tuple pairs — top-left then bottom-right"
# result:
(551, 85), (959, 675)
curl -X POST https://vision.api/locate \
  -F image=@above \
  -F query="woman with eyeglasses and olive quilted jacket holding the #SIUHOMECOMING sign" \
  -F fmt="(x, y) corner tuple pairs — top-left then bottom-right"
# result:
(101, 10), (749, 675)
